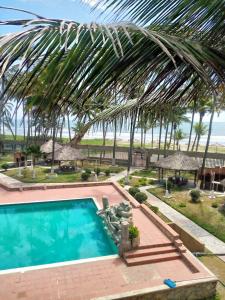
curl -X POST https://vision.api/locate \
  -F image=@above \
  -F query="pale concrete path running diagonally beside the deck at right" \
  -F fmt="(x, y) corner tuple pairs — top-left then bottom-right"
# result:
(140, 187), (225, 262)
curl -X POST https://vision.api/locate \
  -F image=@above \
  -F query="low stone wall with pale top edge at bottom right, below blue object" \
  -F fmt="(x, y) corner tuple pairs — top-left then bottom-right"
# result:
(95, 279), (217, 300)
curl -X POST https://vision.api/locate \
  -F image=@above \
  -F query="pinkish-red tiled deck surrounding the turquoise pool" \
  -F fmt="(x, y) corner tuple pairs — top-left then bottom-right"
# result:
(0, 183), (216, 300)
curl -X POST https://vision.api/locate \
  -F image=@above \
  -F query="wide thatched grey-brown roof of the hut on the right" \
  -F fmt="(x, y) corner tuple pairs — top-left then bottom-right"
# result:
(155, 152), (200, 171)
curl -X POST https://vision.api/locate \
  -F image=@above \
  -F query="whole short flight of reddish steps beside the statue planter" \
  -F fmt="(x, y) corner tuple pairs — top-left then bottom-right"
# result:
(124, 243), (186, 266)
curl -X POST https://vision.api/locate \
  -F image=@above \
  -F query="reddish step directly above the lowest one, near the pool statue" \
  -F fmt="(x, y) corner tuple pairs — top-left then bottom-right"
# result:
(124, 246), (177, 258)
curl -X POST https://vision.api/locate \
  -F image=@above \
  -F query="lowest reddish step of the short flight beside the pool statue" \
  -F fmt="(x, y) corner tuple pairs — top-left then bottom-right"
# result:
(124, 252), (181, 267)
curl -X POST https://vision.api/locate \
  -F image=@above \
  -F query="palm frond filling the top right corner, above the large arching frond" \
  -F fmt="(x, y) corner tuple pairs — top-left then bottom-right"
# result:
(98, 0), (225, 41)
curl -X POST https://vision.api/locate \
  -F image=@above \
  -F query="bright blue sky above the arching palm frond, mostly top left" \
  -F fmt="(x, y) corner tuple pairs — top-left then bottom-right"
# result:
(0, 0), (225, 122)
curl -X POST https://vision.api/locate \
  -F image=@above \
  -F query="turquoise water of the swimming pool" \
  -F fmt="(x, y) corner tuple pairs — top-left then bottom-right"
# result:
(0, 199), (117, 270)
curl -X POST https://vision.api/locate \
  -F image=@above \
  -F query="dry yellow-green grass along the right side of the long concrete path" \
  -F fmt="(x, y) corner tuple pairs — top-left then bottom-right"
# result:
(149, 187), (225, 242)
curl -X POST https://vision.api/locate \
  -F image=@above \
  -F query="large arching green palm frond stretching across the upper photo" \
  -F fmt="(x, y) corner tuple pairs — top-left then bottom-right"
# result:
(0, 7), (224, 119)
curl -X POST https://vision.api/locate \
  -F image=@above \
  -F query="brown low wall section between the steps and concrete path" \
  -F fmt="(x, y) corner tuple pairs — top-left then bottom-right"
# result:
(168, 223), (205, 252)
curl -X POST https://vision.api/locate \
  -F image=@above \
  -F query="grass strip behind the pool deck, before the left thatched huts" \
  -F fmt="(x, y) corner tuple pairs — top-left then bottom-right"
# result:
(4, 167), (108, 183)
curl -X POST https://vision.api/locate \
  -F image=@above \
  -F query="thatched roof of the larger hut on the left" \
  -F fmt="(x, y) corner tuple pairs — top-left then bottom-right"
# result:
(49, 145), (86, 161)
